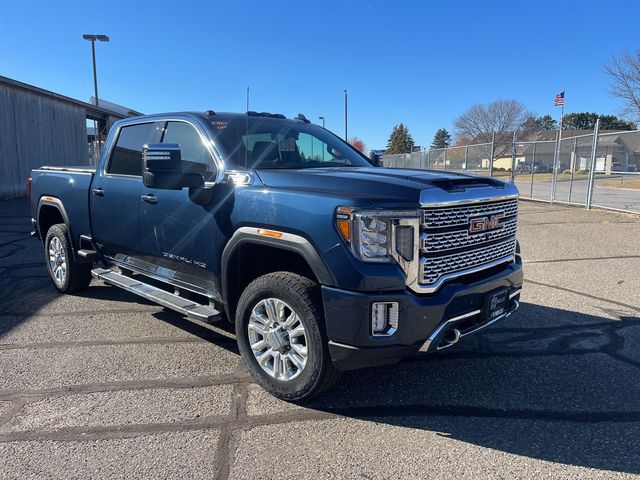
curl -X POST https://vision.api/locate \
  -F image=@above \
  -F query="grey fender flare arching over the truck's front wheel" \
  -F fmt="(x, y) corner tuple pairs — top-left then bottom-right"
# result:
(220, 227), (335, 303)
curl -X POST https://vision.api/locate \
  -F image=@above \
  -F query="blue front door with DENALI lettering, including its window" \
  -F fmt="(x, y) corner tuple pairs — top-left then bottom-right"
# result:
(140, 120), (224, 299)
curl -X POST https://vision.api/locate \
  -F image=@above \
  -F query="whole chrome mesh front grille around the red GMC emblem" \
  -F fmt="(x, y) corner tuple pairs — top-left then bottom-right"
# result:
(418, 198), (518, 289)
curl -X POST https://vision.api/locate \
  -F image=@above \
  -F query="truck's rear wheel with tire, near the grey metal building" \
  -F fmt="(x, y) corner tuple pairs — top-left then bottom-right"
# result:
(44, 223), (91, 293)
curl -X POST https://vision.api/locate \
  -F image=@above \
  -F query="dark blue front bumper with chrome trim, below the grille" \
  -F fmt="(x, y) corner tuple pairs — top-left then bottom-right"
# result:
(322, 255), (523, 370)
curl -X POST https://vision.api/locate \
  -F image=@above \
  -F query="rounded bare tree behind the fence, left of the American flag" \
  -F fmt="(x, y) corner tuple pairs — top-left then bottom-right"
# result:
(453, 99), (532, 143)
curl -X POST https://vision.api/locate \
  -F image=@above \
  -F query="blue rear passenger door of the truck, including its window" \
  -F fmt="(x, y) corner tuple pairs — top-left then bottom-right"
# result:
(90, 122), (161, 262)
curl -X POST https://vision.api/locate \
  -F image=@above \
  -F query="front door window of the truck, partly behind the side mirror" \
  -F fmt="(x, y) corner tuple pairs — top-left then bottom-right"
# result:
(162, 122), (216, 182)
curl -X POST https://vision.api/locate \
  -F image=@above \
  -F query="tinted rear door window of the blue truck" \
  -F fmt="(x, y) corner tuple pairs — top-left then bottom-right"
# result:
(107, 123), (155, 177)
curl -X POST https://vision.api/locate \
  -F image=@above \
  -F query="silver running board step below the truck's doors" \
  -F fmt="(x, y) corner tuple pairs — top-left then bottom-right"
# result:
(91, 268), (222, 323)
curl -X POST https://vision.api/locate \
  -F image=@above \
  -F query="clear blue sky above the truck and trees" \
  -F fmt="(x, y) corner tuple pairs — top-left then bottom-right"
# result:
(0, 0), (640, 148)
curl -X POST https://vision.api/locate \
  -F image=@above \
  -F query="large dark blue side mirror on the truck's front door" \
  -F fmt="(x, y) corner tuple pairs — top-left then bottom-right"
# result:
(142, 143), (204, 190)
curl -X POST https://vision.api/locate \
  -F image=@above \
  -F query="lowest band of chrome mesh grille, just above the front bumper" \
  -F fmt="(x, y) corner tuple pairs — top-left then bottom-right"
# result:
(420, 238), (516, 284)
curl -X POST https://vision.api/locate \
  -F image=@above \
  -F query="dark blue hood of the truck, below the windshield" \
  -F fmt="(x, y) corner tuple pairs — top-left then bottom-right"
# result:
(252, 167), (504, 203)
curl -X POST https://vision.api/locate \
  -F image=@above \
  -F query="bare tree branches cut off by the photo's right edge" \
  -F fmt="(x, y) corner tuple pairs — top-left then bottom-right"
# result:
(604, 50), (640, 121)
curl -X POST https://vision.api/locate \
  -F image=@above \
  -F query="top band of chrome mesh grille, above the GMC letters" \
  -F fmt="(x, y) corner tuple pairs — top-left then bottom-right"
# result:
(422, 199), (518, 229)
